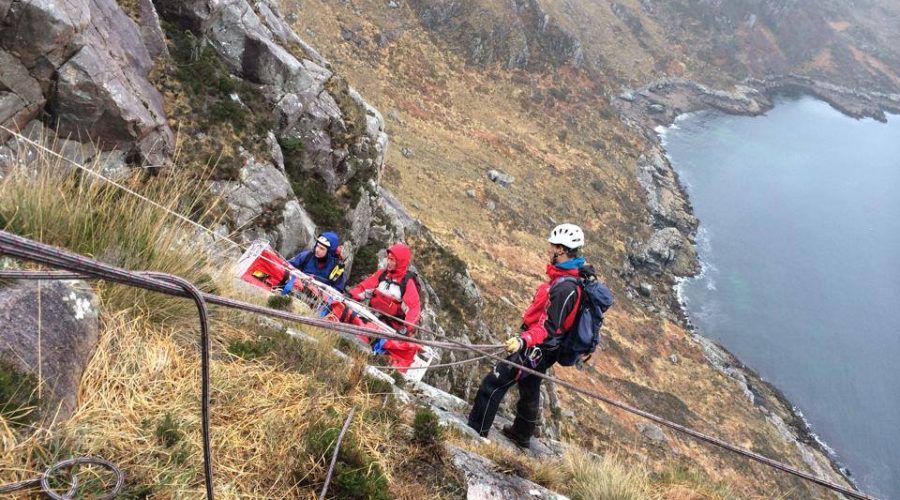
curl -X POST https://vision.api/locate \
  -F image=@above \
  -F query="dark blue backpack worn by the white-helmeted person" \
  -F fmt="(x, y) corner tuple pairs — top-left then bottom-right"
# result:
(557, 273), (613, 366)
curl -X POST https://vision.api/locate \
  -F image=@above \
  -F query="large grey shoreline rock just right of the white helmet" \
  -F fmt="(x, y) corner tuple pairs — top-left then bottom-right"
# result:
(630, 227), (699, 276)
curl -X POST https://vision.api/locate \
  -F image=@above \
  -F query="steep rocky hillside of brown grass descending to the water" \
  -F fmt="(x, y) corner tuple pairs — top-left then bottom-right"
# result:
(0, 0), (900, 498)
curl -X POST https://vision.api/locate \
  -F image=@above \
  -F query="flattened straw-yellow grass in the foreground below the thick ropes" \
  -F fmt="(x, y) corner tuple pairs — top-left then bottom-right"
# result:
(0, 313), (404, 498)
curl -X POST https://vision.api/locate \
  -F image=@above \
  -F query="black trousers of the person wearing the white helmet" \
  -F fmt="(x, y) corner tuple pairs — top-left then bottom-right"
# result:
(469, 352), (556, 440)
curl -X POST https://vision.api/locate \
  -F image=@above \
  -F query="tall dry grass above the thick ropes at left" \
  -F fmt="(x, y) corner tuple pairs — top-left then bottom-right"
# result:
(0, 134), (227, 319)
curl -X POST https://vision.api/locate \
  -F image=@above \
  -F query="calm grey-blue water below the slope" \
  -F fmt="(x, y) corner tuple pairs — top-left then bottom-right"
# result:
(664, 98), (900, 500)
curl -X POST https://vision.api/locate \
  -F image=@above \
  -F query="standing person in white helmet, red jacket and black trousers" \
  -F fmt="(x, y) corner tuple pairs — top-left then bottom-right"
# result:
(468, 224), (585, 448)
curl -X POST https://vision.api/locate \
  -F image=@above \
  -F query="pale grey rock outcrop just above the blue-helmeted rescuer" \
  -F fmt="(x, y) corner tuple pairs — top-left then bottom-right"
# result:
(210, 153), (316, 255)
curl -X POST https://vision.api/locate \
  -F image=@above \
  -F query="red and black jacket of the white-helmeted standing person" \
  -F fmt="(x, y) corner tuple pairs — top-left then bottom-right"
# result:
(521, 264), (581, 347)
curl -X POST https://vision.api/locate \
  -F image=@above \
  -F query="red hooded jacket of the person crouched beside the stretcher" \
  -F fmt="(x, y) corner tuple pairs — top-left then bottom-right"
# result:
(350, 243), (421, 334)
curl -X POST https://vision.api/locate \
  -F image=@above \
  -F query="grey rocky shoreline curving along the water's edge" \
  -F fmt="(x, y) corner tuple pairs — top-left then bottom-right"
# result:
(611, 74), (900, 487)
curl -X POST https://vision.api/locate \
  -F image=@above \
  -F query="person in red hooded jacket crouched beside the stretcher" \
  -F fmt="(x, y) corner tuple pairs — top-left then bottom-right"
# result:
(348, 243), (421, 366)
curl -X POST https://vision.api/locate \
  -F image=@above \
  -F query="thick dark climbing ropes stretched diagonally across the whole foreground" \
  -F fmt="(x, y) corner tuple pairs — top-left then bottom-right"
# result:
(0, 231), (873, 500)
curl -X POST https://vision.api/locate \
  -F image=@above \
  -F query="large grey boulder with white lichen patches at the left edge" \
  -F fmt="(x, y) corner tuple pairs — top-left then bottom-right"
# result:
(0, 281), (100, 420)
